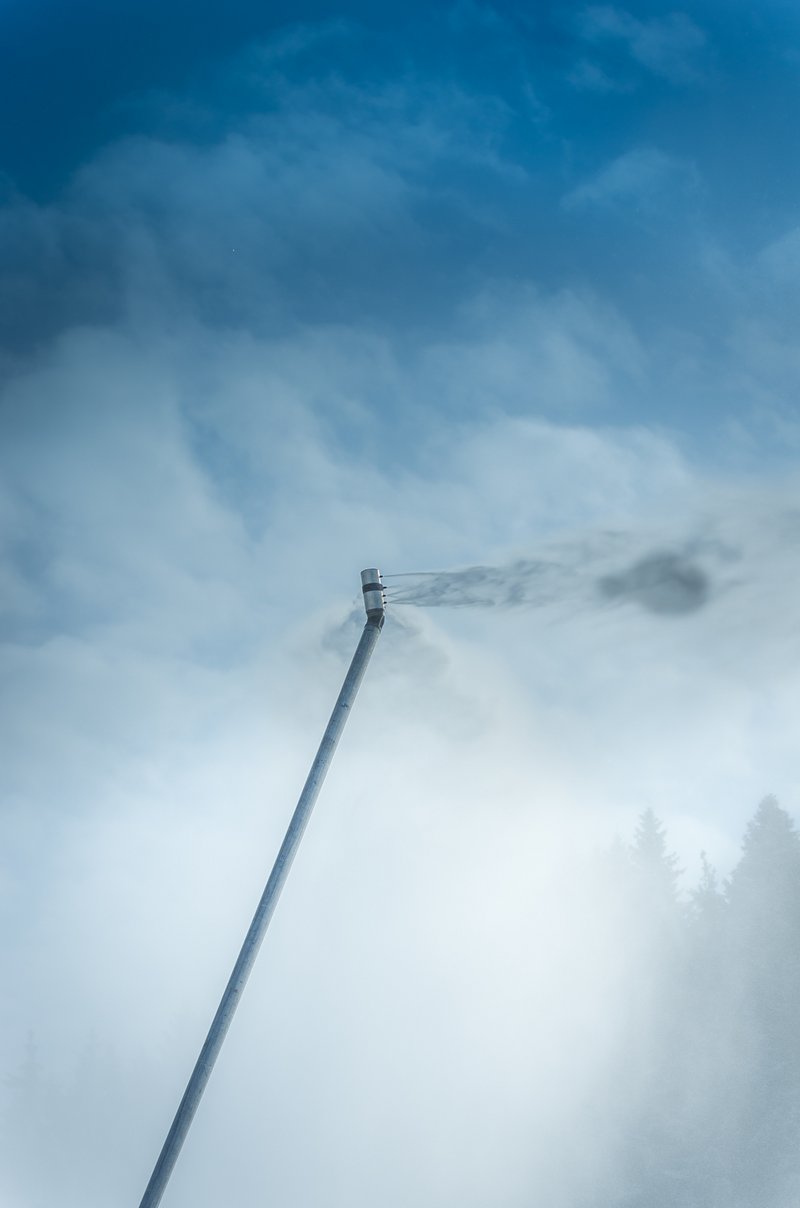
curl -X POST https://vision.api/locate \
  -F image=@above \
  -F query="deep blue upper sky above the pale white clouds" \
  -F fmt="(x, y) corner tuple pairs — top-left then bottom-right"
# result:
(0, 4), (800, 453)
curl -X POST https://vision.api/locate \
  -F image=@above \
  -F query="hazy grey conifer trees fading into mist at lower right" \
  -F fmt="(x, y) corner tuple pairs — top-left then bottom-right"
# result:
(587, 796), (800, 1208)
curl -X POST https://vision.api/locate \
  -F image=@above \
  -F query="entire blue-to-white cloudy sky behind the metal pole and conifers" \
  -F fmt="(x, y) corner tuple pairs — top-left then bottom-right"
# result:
(0, 7), (800, 1208)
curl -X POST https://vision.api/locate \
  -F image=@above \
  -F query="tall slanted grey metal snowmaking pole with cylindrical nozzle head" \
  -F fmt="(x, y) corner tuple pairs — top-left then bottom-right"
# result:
(139, 568), (384, 1208)
